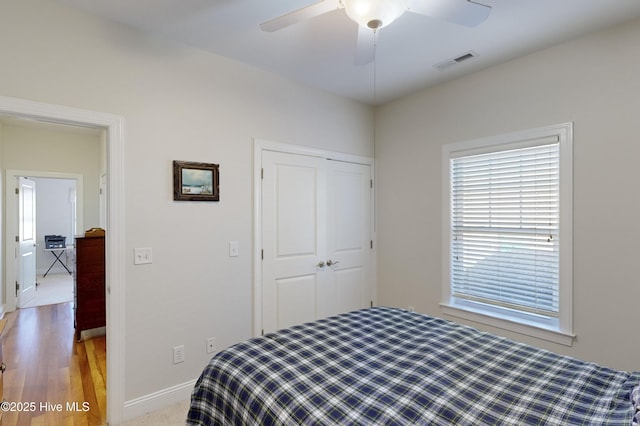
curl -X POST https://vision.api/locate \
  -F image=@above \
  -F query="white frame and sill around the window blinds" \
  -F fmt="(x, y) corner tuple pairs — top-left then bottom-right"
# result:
(440, 122), (575, 346)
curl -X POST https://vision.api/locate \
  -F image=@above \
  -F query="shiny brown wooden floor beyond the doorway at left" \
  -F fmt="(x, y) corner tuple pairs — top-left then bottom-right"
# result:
(2, 303), (107, 426)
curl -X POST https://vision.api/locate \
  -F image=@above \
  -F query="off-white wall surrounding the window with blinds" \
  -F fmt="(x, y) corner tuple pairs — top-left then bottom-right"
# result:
(376, 15), (640, 370)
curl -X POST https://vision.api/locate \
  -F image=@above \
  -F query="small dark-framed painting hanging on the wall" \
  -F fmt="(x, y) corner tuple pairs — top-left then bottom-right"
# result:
(173, 161), (220, 201)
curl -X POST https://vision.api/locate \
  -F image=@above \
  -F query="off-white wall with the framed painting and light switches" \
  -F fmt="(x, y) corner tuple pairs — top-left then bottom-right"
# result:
(0, 0), (373, 410)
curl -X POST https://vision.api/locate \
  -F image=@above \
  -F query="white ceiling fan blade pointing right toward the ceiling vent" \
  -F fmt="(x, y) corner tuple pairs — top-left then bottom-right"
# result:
(407, 0), (491, 27)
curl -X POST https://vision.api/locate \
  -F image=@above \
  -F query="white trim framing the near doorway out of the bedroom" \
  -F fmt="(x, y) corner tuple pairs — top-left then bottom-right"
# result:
(0, 96), (125, 424)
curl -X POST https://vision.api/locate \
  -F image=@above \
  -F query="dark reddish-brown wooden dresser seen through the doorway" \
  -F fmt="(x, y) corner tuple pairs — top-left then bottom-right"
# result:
(74, 237), (106, 341)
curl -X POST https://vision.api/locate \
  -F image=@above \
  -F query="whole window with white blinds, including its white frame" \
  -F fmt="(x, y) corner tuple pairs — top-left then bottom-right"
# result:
(442, 123), (573, 345)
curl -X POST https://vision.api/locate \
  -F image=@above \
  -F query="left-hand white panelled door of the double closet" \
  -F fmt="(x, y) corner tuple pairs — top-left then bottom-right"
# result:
(262, 151), (326, 333)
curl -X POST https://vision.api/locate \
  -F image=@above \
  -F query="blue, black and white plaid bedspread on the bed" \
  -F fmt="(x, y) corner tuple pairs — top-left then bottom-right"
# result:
(187, 308), (640, 426)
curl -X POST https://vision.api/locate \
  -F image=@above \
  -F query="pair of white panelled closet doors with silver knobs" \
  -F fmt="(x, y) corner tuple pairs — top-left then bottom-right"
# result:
(262, 151), (373, 333)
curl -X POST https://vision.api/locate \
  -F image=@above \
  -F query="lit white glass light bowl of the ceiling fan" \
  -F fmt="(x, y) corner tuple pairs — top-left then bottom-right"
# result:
(342, 0), (409, 30)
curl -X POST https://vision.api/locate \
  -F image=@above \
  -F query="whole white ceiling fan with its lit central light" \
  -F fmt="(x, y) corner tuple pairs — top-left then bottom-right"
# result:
(260, 0), (491, 65)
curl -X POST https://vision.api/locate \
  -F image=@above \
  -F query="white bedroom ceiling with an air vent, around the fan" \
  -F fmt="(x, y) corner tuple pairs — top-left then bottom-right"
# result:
(58, 0), (640, 104)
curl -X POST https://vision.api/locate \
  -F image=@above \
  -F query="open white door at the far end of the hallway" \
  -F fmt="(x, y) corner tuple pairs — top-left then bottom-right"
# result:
(16, 177), (36, 308)
